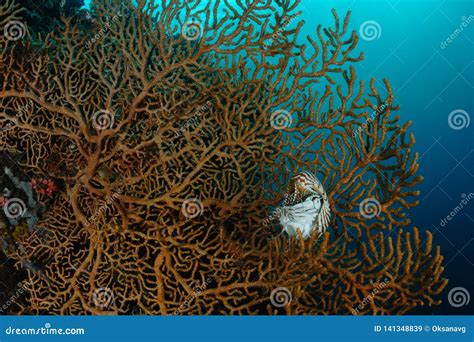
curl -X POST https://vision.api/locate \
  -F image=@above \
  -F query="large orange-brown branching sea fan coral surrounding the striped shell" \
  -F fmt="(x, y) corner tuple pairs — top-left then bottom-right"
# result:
(0, 0), (447, 315)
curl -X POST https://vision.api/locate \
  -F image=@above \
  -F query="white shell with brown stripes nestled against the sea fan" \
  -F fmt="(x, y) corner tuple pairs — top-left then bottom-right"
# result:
(279, 172), (331, 238)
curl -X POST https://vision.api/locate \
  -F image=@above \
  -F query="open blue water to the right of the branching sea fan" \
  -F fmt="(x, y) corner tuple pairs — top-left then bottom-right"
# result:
(86, 0), (474, 314)
